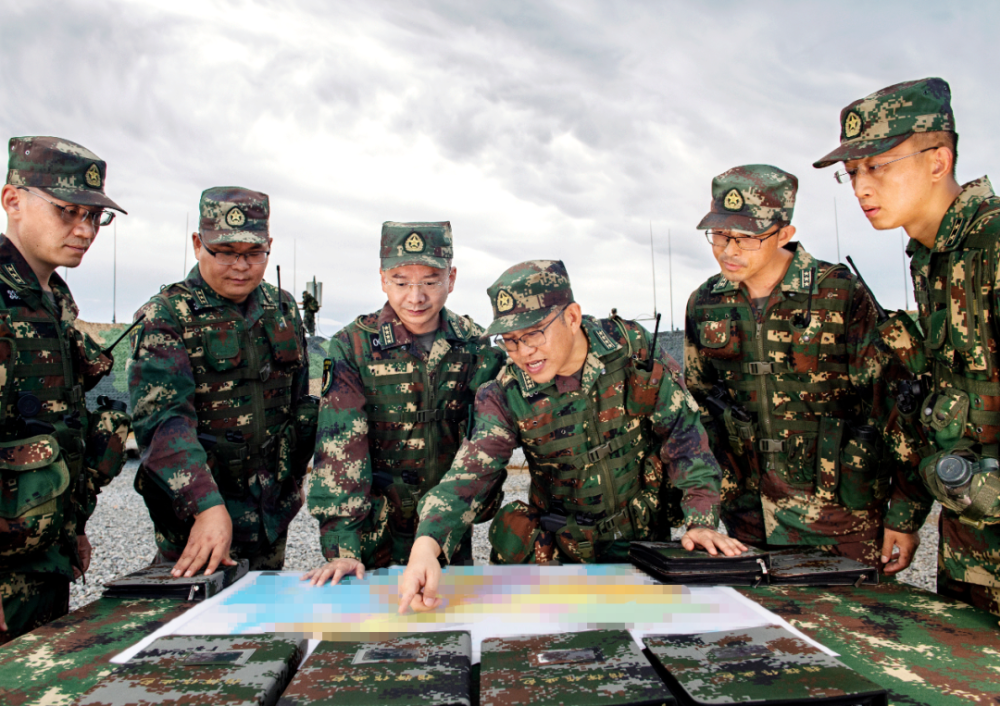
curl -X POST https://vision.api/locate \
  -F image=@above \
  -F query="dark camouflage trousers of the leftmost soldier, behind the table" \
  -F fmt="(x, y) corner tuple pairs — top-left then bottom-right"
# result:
(0, 573), (69, 645)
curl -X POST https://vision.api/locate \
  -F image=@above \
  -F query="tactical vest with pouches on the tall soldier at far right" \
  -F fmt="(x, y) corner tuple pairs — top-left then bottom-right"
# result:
(913, 198), (1000, 528)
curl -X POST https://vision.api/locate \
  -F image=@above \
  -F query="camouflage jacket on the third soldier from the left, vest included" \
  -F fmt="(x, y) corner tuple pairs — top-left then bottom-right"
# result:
(309, 303), (505, 559)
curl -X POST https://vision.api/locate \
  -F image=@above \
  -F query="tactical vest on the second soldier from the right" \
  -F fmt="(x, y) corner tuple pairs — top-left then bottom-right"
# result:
(694, 261), (889, 509)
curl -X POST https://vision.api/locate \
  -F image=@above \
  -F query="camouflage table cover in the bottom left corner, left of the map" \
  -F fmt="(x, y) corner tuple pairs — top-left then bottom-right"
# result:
(0, 598), (196, 706)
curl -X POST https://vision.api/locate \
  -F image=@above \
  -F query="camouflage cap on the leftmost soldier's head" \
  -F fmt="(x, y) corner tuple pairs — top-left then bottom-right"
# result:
(7, 137), (125, 213)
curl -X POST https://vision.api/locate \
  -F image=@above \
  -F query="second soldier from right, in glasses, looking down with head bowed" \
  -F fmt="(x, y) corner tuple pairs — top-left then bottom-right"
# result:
(684, 164), (927, 573)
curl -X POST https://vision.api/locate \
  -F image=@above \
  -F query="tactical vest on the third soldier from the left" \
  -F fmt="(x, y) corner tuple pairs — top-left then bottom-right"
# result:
(356, 317), (477, 506)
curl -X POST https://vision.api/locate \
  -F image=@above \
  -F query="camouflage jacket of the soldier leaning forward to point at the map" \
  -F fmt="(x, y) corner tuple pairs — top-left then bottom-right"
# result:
(418, 316), (720, 558)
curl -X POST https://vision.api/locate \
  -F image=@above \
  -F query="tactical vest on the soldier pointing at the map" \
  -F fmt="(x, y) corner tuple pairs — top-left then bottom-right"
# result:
(500, 317), (662, 540)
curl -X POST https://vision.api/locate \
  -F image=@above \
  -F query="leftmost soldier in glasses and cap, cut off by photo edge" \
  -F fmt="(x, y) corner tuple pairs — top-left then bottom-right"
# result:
(0, 137), (129, 644)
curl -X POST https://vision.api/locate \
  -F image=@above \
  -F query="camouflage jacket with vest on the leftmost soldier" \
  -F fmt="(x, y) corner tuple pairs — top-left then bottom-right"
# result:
(0, 236), (120, 578)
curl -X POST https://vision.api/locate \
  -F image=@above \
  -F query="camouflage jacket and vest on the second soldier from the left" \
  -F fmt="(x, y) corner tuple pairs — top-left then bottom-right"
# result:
(128, 265), (311, 544)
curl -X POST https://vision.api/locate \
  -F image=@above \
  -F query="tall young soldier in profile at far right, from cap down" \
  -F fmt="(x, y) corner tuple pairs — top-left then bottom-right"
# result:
(814, 78), (1000, 615)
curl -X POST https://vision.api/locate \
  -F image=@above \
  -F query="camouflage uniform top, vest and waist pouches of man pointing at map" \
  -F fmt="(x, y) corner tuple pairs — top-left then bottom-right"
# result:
(418, 316), (719, 563)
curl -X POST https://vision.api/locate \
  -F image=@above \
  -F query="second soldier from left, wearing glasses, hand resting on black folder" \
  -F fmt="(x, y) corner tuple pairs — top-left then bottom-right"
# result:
(128, 187), (318, 576)
